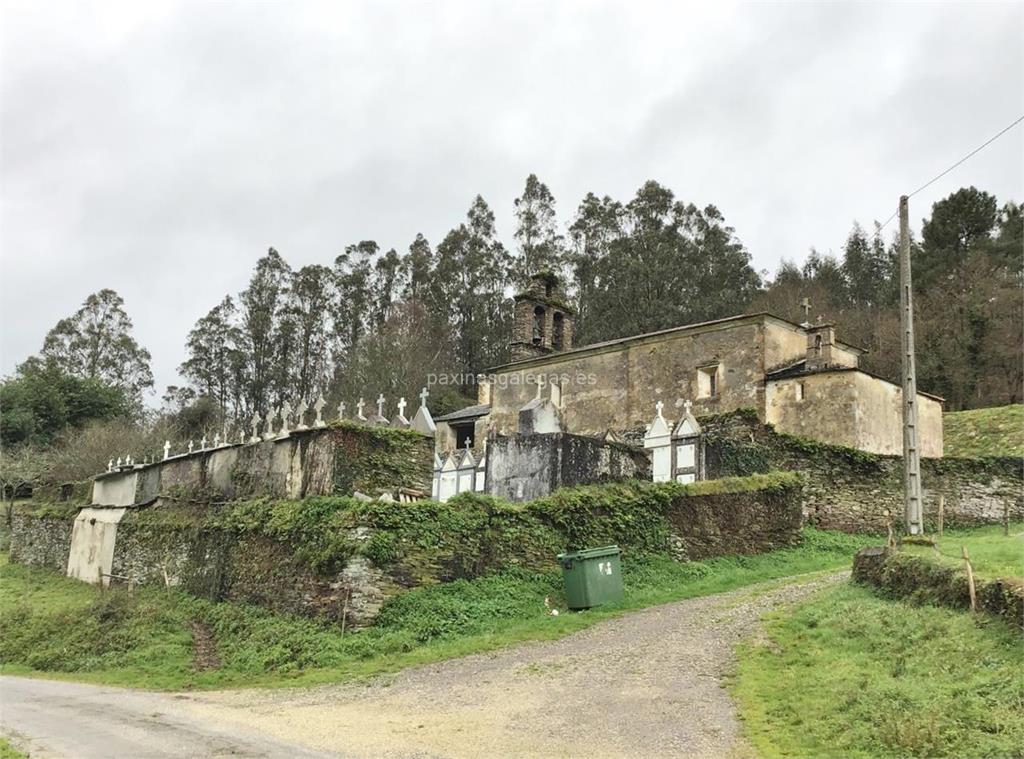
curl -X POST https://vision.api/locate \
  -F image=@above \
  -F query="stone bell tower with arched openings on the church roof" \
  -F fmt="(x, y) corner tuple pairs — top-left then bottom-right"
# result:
(510, 271), (575, 361)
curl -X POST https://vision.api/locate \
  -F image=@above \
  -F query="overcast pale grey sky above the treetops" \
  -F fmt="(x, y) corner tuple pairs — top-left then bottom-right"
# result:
(0, 0), (1024, 392)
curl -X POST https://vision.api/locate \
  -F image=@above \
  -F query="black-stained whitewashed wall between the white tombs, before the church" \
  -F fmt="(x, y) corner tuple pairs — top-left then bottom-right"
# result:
(484, 432), (650, 501)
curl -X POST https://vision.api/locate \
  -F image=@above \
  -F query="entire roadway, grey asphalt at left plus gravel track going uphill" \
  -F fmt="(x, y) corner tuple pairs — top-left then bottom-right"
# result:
(0, 576), (840, 759)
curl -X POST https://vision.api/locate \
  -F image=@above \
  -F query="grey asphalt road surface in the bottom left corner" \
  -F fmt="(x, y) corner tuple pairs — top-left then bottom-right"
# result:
(0, 677), (337, 759)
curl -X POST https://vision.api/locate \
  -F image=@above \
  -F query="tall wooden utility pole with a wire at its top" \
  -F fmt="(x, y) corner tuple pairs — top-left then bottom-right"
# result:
(899, 195), (925, 535)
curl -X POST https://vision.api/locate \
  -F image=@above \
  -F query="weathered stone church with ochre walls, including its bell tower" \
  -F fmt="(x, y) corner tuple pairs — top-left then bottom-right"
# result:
(435, 276), (942, 458)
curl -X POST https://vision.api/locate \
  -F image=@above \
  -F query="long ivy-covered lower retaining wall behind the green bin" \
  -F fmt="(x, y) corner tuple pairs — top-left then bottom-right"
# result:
(11, 473), (800, 627)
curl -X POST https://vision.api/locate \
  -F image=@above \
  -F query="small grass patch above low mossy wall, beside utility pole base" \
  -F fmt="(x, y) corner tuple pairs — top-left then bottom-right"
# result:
(903, 522), (1024, 579)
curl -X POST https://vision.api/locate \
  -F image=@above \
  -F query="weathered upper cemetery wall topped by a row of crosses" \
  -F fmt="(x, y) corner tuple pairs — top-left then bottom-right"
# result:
(92, 423), (433, 506)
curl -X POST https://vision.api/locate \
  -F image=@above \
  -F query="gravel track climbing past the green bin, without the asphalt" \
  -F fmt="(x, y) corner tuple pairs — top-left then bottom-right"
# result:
(181, 575), (843, 759)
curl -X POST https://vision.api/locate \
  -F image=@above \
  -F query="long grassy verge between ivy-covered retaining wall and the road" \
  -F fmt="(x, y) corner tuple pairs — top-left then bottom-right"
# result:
(0, 529), (878, 689)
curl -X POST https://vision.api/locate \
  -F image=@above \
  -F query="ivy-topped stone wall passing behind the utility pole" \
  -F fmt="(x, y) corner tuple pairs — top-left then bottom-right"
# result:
(699, 410), (1024, 532)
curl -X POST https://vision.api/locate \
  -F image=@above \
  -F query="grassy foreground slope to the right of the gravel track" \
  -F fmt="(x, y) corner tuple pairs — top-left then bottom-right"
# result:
(732, 585), (1024, 759)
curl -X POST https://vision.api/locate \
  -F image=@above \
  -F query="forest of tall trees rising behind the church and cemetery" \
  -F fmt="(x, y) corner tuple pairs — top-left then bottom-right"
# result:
(0, 175), (1024, 490)
